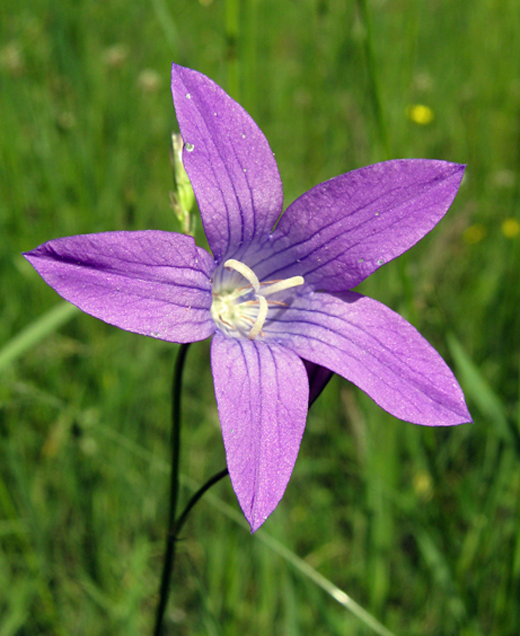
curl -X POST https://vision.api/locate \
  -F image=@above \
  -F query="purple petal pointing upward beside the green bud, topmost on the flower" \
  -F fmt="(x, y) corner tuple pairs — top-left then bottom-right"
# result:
(172, 64), (283, 260)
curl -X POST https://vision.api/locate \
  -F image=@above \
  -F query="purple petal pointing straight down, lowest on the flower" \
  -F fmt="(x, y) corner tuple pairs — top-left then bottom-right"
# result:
(211, 332), (309, 532)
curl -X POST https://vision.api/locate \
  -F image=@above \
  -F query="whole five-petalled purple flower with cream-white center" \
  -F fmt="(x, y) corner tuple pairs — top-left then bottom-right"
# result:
(25, 65), (471, 531)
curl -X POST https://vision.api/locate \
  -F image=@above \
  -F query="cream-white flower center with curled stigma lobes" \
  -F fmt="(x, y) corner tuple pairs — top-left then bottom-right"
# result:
(211, 258), (305, 340)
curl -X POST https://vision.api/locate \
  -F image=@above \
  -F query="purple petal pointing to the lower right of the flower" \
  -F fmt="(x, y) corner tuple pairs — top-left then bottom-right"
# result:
(264, 292), (471, 426)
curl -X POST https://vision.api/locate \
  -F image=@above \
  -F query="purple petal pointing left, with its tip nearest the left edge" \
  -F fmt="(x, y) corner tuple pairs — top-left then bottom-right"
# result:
(24, 230), (215, 342)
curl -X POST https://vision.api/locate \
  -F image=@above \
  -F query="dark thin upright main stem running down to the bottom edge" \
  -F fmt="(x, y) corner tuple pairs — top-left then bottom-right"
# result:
(153, 343), (190, 636)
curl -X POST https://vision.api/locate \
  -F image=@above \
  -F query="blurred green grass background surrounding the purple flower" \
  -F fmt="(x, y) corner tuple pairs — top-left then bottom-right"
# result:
(0, 0), (520, 636)
